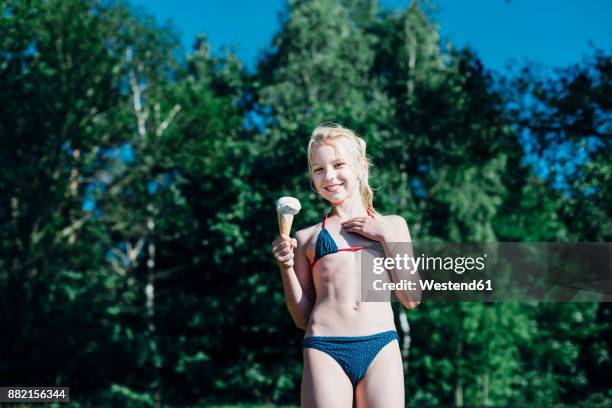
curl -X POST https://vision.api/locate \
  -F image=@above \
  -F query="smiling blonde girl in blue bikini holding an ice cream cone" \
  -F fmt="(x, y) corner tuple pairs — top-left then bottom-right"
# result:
(272, 125), (419, 408)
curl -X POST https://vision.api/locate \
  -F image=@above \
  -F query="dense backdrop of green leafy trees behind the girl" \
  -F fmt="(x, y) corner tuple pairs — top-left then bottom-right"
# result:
(0, 0), (612, 407)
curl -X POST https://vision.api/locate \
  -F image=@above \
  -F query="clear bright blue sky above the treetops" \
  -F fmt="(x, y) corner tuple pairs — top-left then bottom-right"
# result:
(132, 0), (612, 70)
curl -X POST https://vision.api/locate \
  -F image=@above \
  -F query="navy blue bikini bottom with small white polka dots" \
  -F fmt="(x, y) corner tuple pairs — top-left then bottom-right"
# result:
(303, 330), (399, 387)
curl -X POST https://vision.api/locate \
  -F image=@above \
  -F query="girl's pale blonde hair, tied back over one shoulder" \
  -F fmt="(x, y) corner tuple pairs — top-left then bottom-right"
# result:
(308, 123), (376, 213)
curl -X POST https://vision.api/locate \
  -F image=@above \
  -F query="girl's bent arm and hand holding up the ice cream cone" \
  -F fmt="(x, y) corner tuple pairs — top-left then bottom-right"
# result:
(273, 230), (315, 330)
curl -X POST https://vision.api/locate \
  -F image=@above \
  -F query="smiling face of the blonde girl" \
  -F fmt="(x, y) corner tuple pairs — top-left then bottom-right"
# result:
(311, 143), (358, 204)
